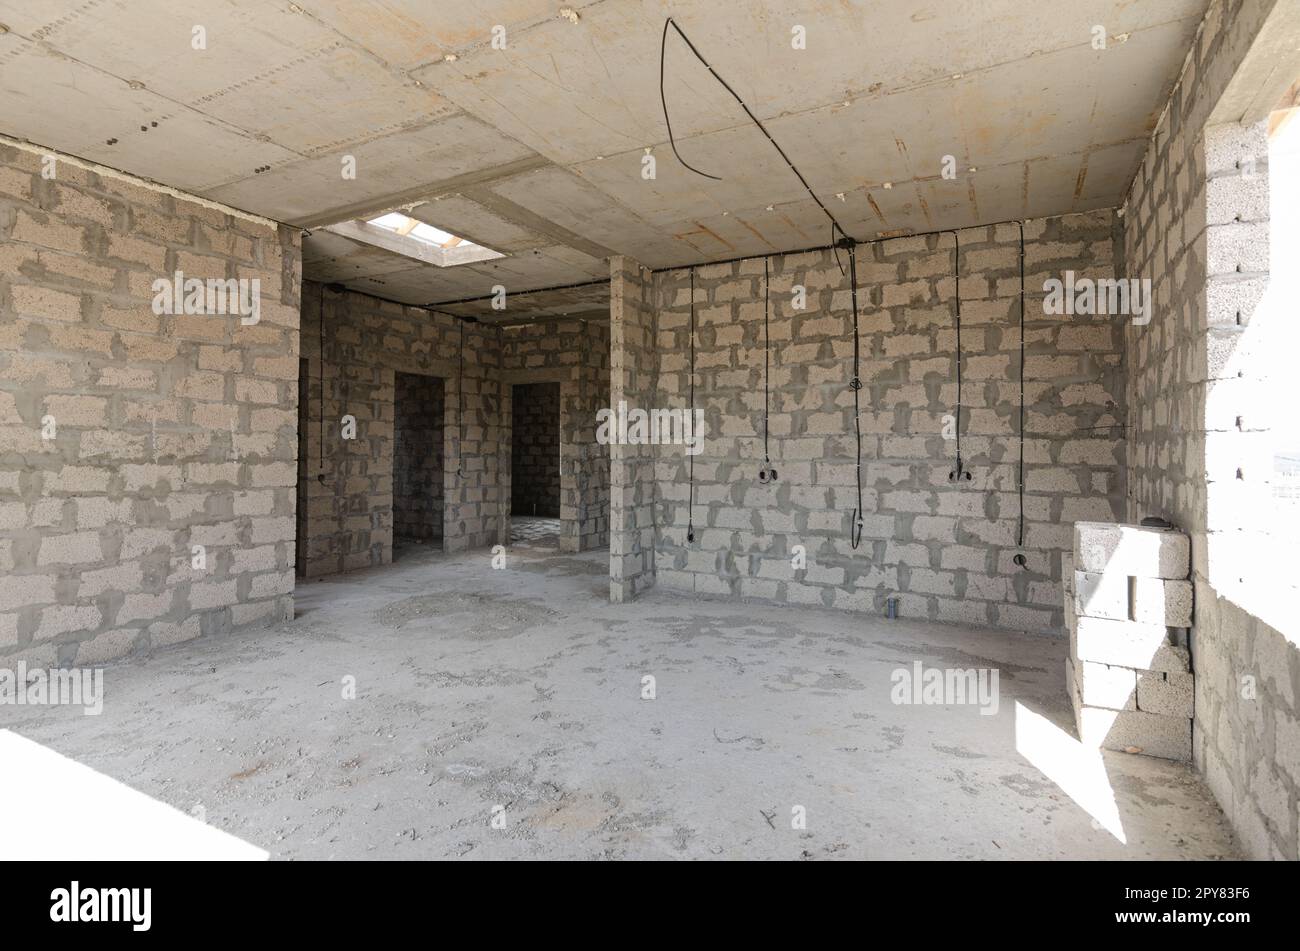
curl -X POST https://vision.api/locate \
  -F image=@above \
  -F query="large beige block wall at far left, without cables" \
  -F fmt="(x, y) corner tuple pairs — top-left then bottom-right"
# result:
(0, 144), (302, 666)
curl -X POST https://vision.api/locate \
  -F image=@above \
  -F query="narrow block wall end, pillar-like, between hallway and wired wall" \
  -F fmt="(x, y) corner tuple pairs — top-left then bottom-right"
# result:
(610, 255), (660, 603)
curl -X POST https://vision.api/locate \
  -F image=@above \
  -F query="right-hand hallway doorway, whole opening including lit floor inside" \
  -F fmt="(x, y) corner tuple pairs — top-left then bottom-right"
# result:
(510, 383), (560, 548)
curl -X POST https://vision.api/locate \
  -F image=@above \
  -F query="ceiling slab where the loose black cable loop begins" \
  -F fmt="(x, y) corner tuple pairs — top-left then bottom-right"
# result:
(416, 0), (1206, 165)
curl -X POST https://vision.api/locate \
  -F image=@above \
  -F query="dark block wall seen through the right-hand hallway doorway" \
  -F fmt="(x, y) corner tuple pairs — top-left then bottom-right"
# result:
(510, 383), (560, 518)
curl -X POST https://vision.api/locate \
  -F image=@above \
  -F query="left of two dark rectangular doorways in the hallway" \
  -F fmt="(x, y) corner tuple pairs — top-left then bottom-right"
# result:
(393, 373), (446, 560)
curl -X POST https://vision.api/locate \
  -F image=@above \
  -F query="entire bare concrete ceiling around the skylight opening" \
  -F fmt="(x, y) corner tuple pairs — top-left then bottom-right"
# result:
(0, 0), (1208, 317)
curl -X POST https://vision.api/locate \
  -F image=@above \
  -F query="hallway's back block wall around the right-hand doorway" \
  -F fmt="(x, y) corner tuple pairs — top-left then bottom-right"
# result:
(502, 320), (610, 552)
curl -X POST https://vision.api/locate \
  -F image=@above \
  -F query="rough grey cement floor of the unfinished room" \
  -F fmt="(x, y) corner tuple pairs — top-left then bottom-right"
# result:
(0, 548), (1236, 859)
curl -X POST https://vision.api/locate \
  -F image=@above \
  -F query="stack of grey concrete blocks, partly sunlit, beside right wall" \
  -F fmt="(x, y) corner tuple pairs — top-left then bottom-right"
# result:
(1065, 522), (1193, 760)
